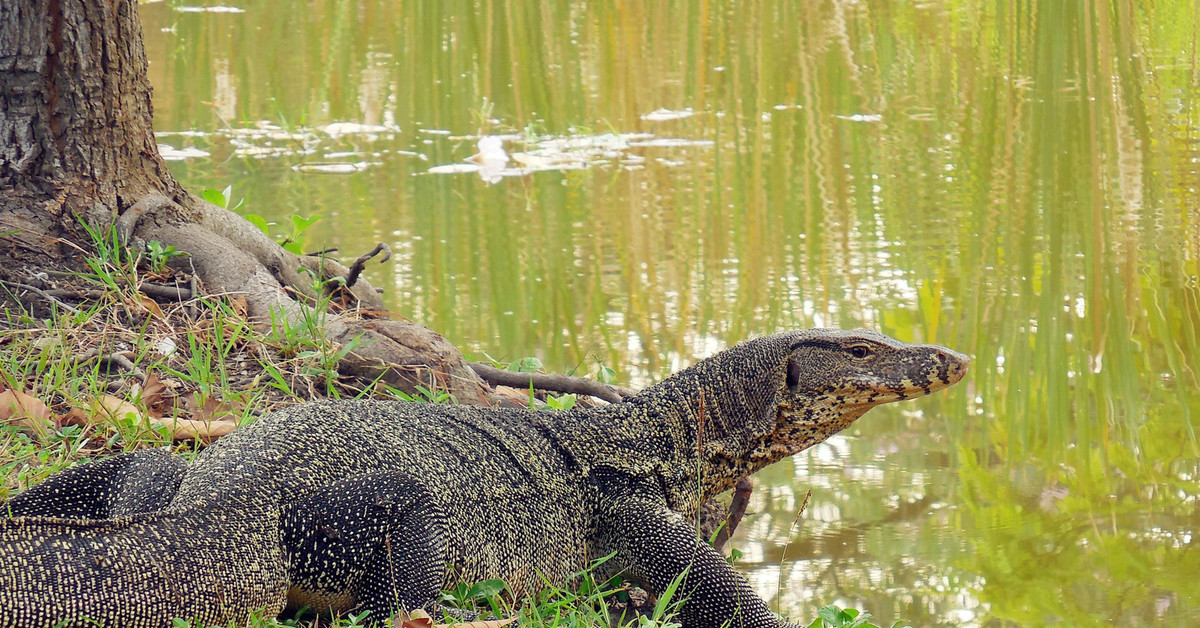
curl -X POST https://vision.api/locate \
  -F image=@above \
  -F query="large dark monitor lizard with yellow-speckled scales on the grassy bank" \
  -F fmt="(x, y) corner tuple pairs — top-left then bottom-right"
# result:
(0, 329), (967, 628)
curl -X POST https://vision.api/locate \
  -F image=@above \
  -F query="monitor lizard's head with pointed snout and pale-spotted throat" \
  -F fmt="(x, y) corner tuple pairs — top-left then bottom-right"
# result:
(734, 329), (971, 467)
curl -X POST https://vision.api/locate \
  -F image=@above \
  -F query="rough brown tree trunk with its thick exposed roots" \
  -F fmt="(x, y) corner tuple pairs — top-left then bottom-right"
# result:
(0, 0), (496, 403)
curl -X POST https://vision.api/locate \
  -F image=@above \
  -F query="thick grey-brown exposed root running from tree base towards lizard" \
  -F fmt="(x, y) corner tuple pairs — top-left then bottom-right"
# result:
(115, 193), (498, 405)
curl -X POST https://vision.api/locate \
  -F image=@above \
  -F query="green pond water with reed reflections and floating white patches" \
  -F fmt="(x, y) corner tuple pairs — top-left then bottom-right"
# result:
(142, 0), (1200, 626)
